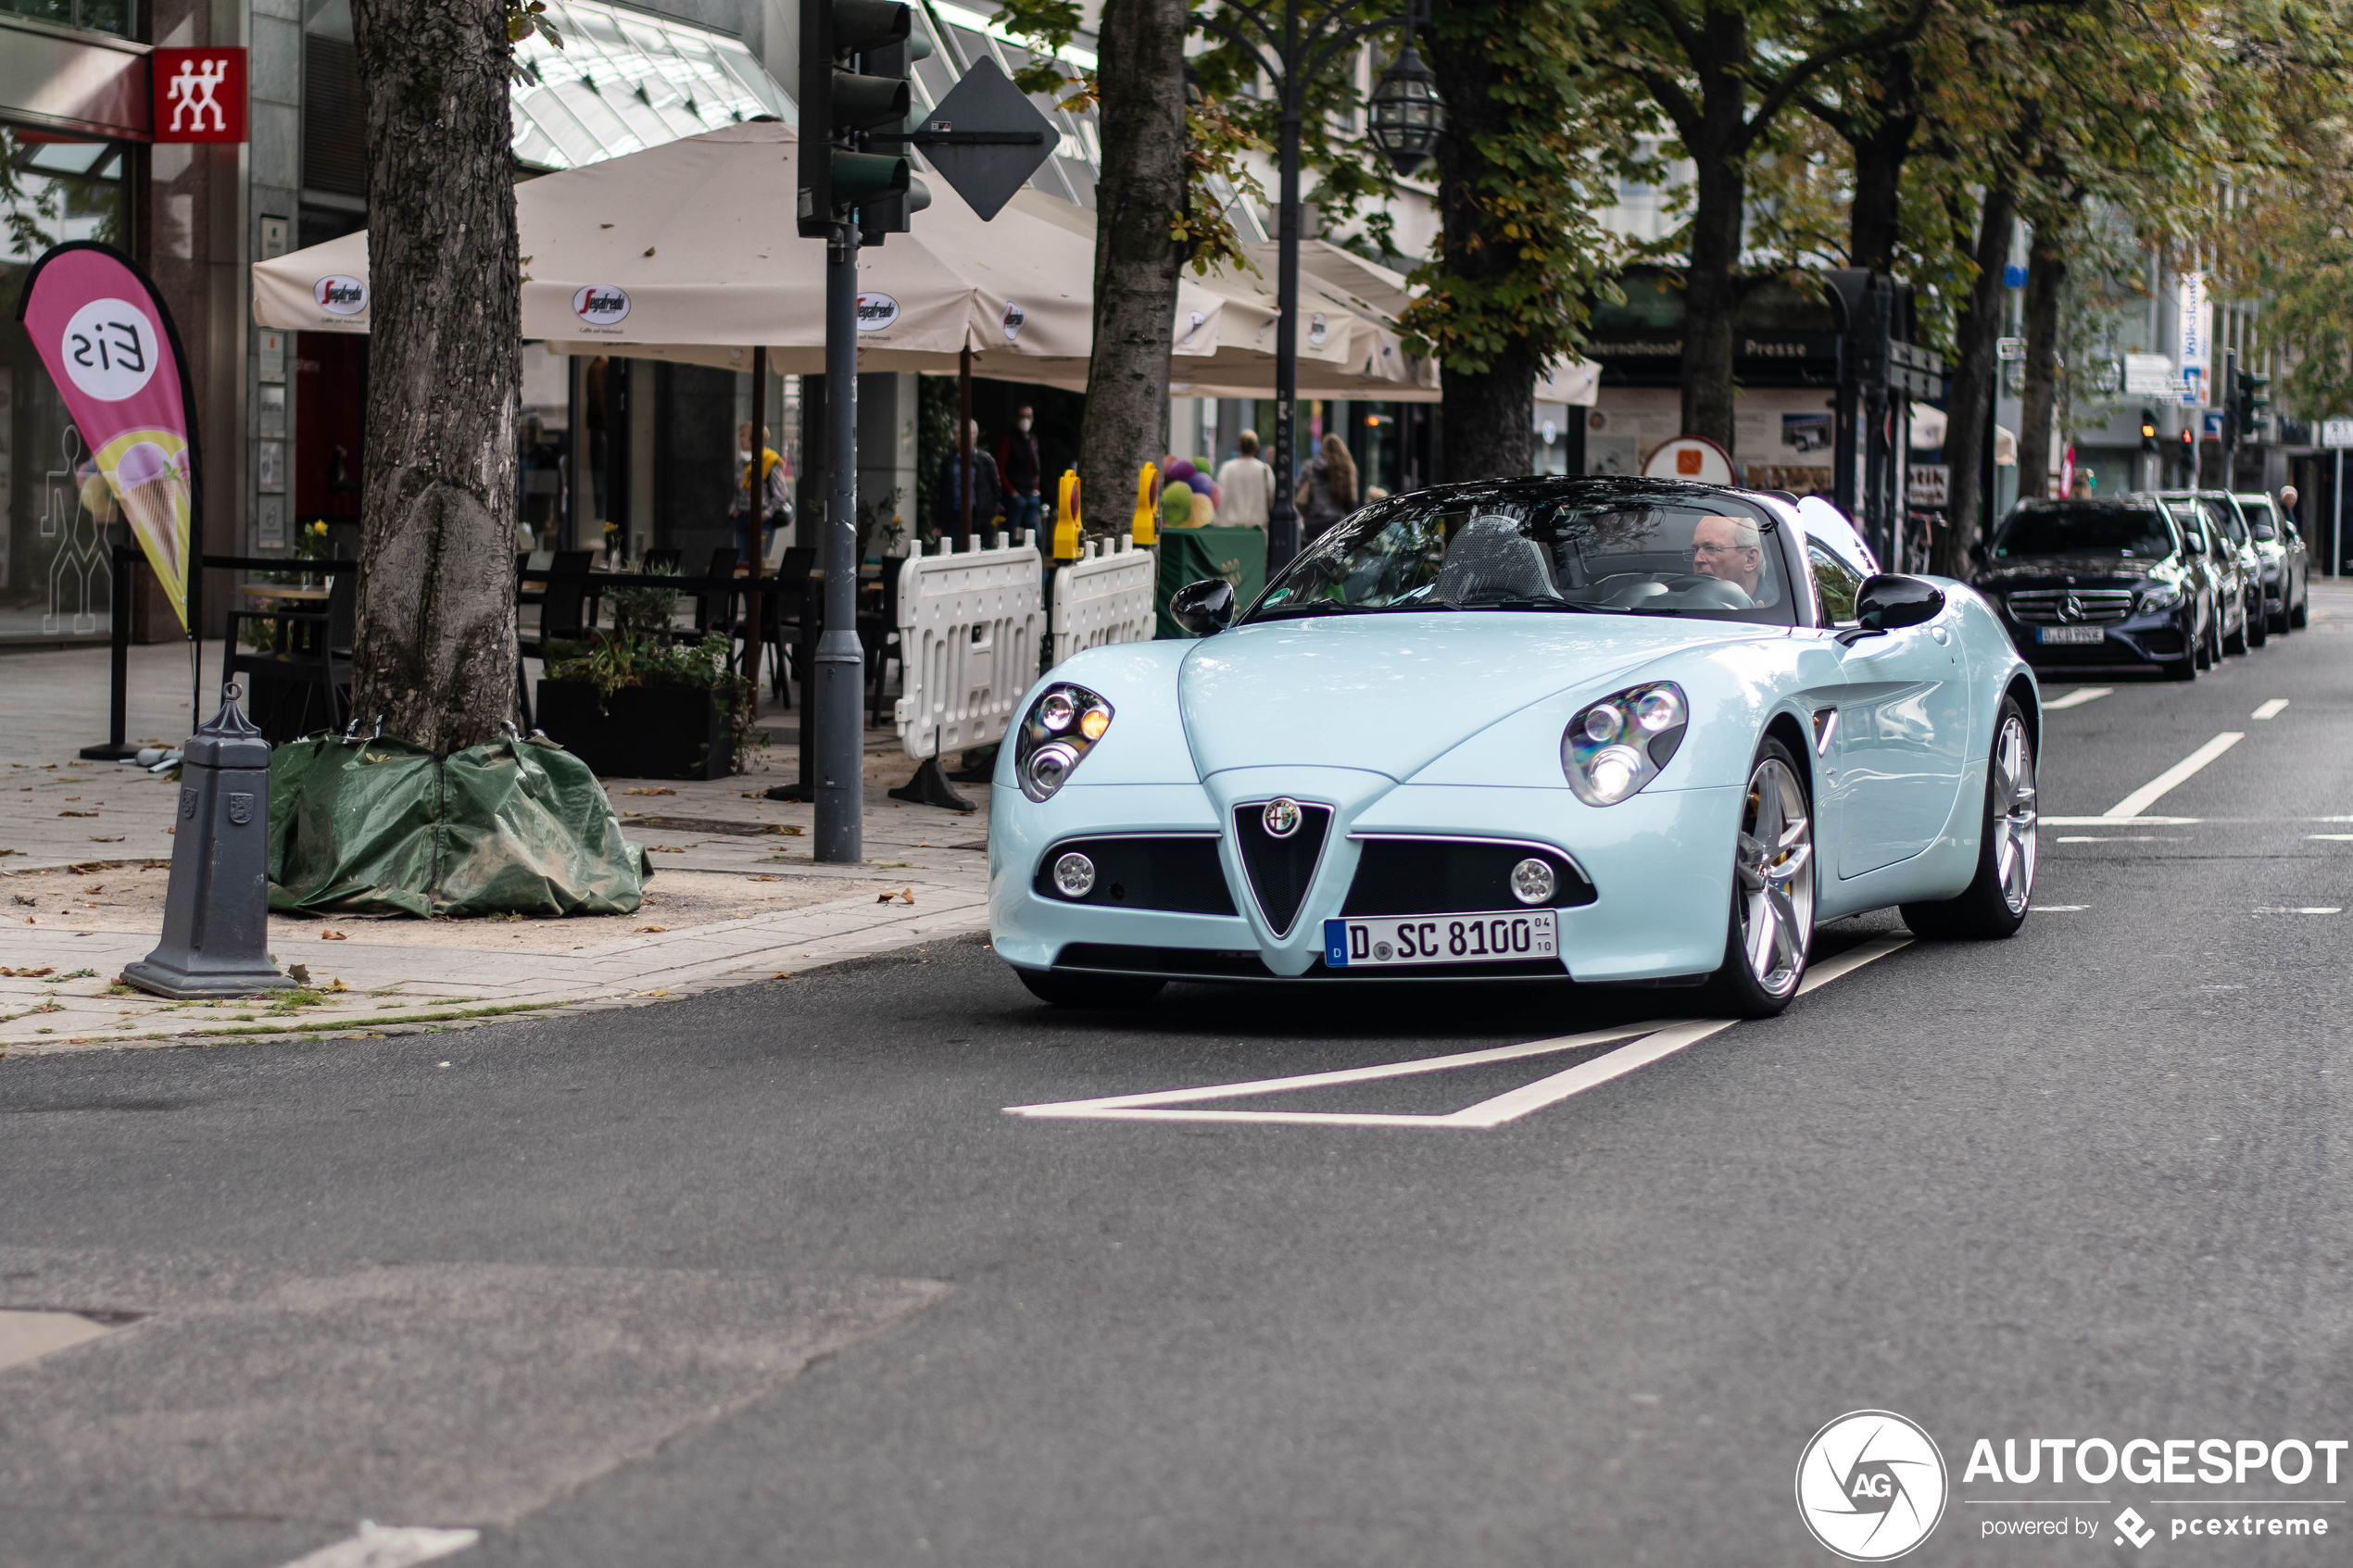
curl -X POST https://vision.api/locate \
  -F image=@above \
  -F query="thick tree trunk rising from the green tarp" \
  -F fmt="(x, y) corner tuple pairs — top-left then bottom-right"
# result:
(350, 0), (522, 755)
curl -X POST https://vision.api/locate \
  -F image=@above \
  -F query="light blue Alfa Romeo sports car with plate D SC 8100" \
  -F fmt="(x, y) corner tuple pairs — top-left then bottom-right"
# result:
(988, 477), (2043, 1016)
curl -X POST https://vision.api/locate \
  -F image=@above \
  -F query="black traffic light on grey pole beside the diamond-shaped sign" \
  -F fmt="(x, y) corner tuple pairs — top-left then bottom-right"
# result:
(796, 0), (915, 240)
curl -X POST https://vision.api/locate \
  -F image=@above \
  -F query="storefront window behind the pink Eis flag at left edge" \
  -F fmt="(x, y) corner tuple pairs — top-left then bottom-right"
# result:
(0, 125), (122, 639)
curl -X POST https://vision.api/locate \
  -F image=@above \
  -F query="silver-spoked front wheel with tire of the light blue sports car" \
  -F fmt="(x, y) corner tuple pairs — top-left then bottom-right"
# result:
(1708, 738), (1814, 1018)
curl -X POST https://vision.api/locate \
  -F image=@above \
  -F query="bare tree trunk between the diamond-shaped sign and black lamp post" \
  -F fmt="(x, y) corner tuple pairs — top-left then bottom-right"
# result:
(1077, 0), (1195, 527)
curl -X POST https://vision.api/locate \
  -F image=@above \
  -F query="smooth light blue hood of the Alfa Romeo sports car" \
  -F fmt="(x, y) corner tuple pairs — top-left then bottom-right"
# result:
(1176, 611), (1788, 778)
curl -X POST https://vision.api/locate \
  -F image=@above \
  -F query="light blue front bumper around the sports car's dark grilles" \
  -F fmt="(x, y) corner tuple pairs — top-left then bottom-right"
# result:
(988, 769), (1742, 980)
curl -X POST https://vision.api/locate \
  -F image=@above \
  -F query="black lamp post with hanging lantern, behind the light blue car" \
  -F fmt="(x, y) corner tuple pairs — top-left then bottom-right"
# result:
(1193, 0), (1447, 573)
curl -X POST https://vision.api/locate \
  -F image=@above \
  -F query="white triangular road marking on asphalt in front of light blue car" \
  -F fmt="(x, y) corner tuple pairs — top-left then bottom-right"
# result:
(1005, 935), (1910, 1128)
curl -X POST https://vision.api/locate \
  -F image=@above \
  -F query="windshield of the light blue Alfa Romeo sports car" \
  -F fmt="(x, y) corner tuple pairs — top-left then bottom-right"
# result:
(1250, 482), (1812, 625)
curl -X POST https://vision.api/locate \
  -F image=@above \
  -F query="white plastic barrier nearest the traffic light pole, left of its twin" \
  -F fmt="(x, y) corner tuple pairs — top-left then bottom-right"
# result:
(892, 532), (1045, 761)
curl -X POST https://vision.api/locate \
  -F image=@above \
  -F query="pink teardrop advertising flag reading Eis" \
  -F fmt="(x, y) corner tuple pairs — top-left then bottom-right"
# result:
(17, 240), (202, 628)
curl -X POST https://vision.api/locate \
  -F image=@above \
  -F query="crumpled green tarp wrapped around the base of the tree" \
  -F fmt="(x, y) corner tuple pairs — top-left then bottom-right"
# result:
(271, 734), (652, 917)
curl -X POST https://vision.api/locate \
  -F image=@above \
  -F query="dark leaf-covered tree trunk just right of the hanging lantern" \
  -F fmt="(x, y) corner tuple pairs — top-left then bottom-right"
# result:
(1421, 17), (1543, 482)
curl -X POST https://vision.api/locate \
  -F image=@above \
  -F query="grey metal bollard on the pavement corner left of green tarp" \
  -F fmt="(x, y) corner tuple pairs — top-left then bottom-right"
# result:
(122, 684), (295, 997)
